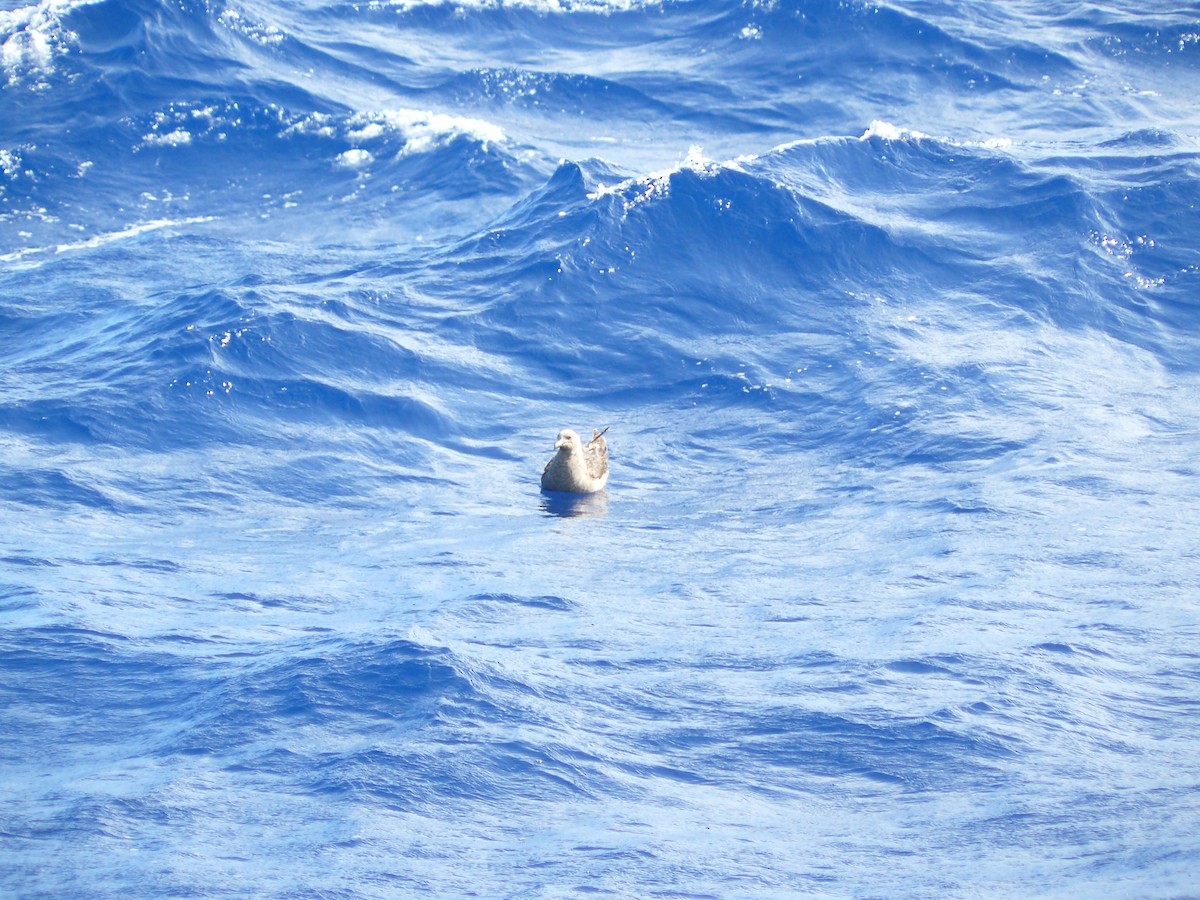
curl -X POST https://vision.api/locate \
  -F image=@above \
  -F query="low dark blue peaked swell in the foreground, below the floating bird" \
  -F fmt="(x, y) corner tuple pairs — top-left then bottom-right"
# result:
(193, 642), (638, 815)
